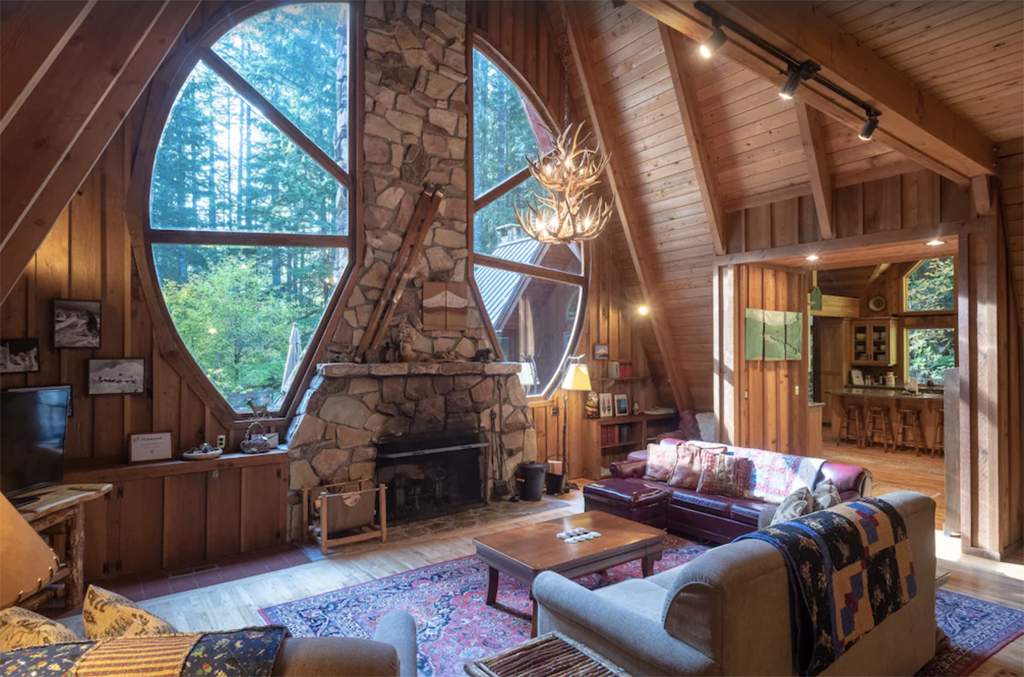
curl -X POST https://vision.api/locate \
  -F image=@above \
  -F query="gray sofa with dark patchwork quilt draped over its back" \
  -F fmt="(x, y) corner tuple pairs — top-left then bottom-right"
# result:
(534, 492), (936, 677)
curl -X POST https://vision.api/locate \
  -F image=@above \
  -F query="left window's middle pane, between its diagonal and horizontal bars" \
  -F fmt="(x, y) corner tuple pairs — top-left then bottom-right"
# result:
(151, 62), (348, 235)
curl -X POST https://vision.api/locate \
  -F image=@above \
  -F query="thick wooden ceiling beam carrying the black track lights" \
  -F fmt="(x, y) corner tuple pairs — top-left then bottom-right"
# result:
(629, 0), (995, 185)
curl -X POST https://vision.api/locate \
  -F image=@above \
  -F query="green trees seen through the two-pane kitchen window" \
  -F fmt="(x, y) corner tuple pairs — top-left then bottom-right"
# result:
(906, 257), (956, 383)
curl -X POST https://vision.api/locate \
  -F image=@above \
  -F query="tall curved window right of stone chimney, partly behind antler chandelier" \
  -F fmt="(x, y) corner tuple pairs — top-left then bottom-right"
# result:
(473, 49), (586, 395)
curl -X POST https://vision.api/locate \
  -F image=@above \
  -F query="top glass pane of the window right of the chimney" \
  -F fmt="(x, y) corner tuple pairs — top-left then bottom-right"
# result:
(473, 51), (538, 197)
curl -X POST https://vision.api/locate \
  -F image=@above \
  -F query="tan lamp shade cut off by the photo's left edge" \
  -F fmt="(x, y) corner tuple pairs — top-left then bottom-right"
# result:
(0, 495), (59, 608)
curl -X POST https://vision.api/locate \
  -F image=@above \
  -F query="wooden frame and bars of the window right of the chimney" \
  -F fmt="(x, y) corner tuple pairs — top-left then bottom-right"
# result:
(466, 35), (592, 401)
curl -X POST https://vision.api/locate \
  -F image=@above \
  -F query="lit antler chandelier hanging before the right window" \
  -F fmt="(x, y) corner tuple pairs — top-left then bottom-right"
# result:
(515, 124), (611, 244)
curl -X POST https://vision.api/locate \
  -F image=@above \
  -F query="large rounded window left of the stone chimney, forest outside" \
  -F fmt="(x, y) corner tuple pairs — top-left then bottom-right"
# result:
(146, 2), (352, 412)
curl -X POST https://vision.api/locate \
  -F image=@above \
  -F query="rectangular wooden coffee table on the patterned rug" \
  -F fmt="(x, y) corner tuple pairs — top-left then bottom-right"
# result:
(473, 511), (665, 637)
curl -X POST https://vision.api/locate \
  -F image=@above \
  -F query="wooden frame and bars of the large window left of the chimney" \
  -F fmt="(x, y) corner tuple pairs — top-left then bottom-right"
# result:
(125, 0), (366, 427)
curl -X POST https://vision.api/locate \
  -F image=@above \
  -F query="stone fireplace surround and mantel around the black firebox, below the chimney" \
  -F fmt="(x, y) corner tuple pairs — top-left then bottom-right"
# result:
(288, 362), (537, 538)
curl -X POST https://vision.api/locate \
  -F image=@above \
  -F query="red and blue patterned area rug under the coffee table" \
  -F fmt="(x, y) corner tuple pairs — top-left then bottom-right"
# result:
(260, 537), (1024, 677)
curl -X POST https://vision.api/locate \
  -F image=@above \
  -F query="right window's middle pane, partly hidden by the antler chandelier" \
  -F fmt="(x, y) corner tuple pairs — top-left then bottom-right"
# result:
(473, 178), (583, 273)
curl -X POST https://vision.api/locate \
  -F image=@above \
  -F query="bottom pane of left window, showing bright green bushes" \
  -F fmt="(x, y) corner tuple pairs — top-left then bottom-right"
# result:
(153, 245), (348, 411)
